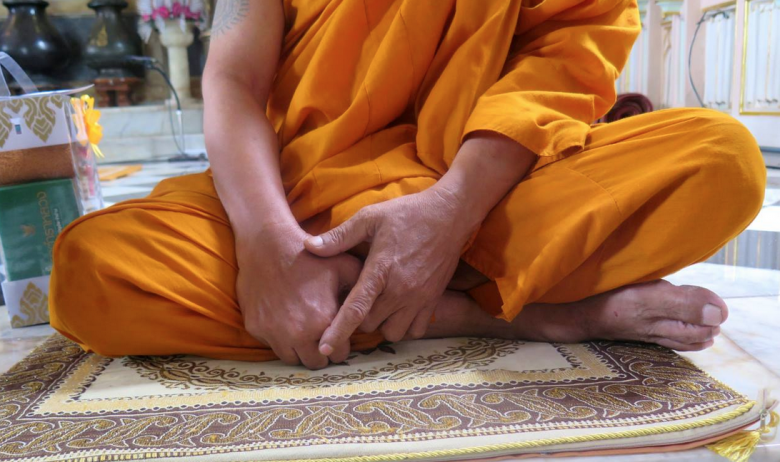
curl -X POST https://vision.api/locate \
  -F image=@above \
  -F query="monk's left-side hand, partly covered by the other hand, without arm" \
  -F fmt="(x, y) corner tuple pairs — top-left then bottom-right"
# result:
(236, 228), (361, 369)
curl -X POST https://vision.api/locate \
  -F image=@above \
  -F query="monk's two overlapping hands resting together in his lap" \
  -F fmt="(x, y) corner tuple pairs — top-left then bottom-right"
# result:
(236, 186), (479, 369)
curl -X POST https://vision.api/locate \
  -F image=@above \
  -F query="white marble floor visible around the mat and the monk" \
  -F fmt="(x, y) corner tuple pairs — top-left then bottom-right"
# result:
(0, 162), (780, 462)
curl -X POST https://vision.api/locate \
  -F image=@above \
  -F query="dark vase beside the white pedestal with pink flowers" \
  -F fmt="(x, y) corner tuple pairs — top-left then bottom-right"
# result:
(84, 0), (141, 77)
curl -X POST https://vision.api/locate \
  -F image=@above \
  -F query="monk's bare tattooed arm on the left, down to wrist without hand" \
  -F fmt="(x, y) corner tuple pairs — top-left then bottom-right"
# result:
(203, 0), (302, 240)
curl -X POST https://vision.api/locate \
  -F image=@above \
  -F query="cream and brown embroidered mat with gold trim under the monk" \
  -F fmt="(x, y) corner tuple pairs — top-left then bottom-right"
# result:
(0, 335), (758, 462)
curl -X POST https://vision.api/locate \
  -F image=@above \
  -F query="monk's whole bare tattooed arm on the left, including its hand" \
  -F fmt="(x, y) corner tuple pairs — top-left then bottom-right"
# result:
(203, 0), (361, 369)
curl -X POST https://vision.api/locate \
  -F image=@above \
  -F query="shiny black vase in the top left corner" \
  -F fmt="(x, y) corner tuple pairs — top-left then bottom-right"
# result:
(0, 0), (71, 80)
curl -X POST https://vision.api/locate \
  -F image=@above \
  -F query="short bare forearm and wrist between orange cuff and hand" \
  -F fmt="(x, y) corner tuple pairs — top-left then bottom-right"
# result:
(435, 132), (536, 226)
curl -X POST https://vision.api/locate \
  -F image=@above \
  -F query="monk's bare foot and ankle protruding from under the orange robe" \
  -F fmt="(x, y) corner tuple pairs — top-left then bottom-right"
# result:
(426, 280), (728, 351)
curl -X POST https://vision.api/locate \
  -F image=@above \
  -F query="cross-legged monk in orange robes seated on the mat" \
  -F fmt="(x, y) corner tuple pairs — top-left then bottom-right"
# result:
(50, 0), (766, 369)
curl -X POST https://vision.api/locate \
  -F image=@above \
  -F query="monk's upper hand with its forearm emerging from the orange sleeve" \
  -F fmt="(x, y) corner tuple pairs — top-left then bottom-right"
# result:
(305, 132), (536, 355)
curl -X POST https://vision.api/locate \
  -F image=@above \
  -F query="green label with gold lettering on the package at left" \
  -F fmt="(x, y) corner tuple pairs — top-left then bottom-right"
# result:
(0, 179), (80, 281)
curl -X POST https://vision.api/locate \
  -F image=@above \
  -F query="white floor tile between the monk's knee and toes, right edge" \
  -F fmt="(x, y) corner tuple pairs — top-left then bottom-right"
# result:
(664, 263), (780, 298)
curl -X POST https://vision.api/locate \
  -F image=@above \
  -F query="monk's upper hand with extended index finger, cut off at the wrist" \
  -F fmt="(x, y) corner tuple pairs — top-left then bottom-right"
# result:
(306, 186), (475, 355)
